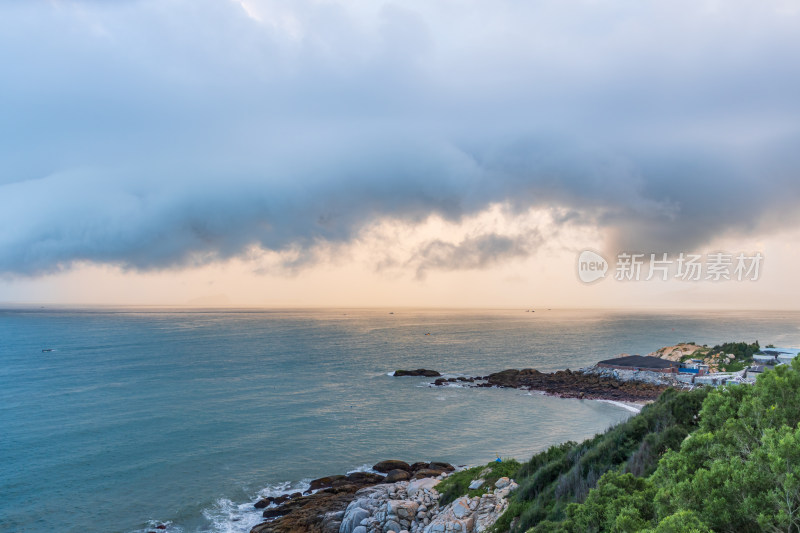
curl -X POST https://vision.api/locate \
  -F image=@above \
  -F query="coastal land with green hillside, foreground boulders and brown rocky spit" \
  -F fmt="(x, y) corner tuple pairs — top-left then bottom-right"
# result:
(247, 340), (800, 533)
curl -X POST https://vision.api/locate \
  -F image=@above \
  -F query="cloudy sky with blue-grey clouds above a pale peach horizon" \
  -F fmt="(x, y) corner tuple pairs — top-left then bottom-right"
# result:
(0, 0), (800, 309)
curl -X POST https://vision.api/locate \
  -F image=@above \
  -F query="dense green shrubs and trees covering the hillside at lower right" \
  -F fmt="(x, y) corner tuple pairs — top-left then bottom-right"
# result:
(495, 358), (800, 533)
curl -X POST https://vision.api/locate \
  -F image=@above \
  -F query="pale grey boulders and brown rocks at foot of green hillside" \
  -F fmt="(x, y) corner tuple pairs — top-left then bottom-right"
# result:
(245, 460), (517, 533)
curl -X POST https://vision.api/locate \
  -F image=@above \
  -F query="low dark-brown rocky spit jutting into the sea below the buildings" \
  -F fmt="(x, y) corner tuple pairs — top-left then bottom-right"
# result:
(393, 367), (683, 403)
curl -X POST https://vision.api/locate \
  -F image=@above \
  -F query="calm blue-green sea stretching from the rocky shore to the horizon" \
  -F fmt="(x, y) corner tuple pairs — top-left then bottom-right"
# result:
(0, 308), (800, 532)
